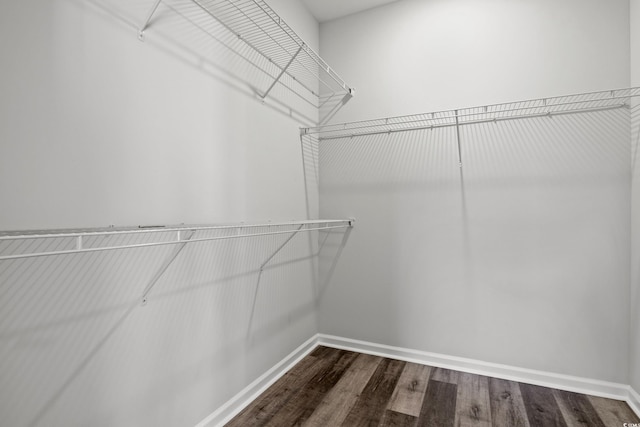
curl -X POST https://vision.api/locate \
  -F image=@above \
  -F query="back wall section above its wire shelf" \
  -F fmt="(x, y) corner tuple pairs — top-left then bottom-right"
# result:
(320, 0), (629, 122)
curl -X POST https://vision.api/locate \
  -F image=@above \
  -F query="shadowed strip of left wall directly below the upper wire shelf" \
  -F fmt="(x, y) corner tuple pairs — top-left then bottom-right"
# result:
(77, 0), (322, 125)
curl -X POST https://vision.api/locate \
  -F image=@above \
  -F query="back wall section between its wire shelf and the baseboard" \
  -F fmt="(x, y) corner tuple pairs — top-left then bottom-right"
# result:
(319, 108), (630, 372)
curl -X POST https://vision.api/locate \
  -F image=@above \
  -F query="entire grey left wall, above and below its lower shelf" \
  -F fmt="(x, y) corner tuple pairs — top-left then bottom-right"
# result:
(0, 0), (324, 426)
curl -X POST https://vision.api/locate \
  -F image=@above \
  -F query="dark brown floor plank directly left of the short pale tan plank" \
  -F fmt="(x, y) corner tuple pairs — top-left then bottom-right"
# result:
(342, 359), (406, 427)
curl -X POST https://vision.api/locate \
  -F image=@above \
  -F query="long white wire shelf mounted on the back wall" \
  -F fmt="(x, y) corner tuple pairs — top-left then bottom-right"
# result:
(301, 87), (640, 141)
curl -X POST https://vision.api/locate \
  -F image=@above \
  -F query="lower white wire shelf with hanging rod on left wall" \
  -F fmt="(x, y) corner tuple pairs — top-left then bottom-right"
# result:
(0, 219), (354, 261)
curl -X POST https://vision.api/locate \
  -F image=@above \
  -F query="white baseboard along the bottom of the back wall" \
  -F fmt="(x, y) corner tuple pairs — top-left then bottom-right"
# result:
(318, 334), (630, 401)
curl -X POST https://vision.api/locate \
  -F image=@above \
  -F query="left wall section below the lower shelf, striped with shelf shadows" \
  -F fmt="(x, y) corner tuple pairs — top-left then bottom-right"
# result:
(0, 227), (347, 426)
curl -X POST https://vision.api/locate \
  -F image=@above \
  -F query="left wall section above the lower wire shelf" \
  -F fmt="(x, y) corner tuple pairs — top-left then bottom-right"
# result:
(0, 0), (320, 229)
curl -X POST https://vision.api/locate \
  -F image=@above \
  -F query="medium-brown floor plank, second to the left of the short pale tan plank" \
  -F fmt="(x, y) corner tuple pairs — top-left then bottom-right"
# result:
(304, 354), (382, 427)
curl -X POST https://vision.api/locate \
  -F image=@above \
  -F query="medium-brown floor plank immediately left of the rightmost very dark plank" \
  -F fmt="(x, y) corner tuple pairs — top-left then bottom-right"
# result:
(489, 378), (530, 427)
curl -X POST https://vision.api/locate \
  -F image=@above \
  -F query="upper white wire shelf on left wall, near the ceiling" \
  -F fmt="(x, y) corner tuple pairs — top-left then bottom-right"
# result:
(139, 0), (353, 123)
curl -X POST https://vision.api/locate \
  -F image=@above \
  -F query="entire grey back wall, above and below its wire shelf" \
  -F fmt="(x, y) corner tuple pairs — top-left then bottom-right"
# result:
(319, 0), (630, 383)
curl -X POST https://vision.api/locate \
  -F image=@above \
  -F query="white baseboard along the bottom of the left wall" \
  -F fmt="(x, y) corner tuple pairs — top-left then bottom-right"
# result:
(196, 335), (318, 427)
